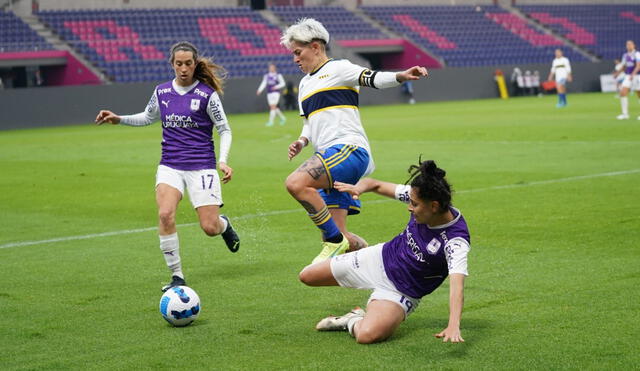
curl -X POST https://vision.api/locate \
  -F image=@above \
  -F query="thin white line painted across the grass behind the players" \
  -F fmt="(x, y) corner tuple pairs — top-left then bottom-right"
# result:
(0, 169), (640, 249)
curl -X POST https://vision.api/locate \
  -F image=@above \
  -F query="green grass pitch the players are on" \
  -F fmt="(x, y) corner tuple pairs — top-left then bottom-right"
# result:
(0, 94), (640, 370)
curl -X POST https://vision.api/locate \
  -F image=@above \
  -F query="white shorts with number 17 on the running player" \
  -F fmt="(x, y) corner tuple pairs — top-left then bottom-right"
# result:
(156, 165), (223, 208)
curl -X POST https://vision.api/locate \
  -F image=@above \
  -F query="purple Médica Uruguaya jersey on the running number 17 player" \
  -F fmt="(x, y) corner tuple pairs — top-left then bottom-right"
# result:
(156, 81), (220, 170)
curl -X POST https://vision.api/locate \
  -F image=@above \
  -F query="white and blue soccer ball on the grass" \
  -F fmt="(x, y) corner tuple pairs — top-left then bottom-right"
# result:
(160, 286), (200, 327)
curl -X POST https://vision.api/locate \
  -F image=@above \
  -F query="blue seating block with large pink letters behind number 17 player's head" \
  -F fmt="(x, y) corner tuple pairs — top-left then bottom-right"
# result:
(38, 7), (292, 82)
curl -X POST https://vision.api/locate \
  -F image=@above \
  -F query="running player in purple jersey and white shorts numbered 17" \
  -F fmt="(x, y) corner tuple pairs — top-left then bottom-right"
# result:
(96, 41), (240, 291)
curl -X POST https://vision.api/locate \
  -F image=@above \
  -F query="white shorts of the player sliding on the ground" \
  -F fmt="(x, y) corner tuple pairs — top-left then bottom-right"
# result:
(331, 243), (420, 318)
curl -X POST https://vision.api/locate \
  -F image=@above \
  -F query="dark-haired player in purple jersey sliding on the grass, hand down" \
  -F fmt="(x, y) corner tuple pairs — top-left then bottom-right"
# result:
(300, 160), (470, 344)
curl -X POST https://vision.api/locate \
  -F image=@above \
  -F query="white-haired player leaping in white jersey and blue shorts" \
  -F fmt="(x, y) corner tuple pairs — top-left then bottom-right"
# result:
(281, 18), (427, 262)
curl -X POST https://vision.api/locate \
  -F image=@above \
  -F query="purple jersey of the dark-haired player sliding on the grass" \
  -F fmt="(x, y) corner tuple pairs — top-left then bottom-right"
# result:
(382, 207), (471, 299)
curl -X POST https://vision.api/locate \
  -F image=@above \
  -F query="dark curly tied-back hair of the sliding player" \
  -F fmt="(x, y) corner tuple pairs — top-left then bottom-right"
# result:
(407, 157), (452, 212)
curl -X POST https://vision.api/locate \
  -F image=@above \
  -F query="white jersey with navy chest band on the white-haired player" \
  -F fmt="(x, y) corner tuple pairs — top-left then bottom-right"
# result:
(298, 59), (392, 175)
